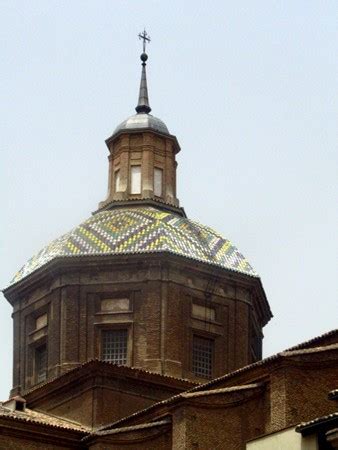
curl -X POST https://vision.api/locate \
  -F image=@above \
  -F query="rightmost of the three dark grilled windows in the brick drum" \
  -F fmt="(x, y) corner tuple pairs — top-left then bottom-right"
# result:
(192, 336), (214, 378)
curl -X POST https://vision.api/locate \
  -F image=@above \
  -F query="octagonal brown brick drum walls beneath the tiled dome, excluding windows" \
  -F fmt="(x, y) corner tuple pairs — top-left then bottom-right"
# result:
(4, 255), (266, 395)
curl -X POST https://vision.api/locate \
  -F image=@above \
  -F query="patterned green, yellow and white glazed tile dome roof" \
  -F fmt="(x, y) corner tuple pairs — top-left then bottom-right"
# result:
(10, 207), (258, 284)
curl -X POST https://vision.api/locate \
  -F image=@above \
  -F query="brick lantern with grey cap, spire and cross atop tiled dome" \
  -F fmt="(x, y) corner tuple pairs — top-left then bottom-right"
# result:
(99, 31), (185, 216)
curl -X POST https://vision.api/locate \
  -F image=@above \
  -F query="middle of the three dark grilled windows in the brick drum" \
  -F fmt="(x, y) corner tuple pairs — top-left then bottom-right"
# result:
(102, 330), (128, 364)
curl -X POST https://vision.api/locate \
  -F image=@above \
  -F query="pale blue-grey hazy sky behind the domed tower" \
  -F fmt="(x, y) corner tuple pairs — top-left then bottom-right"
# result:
(0, 0), (338, 399)
